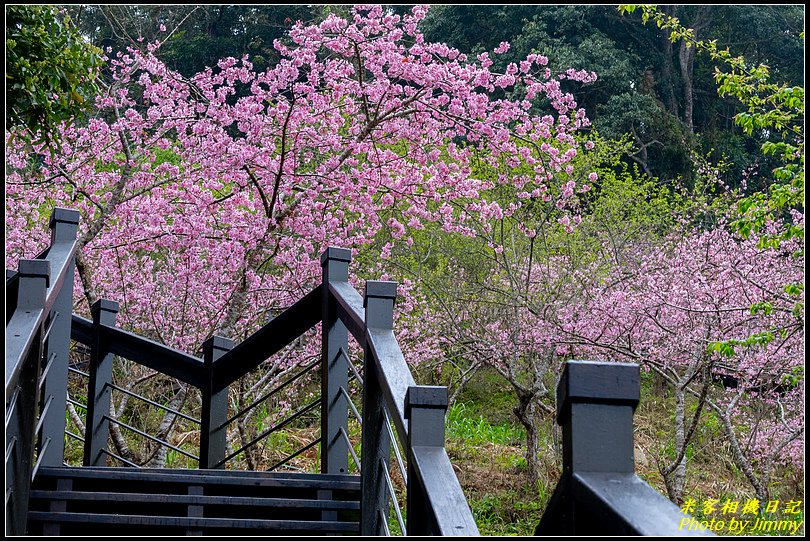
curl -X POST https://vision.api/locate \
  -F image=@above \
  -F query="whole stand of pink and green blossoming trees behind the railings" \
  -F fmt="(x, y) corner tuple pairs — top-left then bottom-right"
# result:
(6, 6), (804, 510)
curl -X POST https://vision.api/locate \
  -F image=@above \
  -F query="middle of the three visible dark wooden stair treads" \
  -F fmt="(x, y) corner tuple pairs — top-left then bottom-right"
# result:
(31, 486), (360, 511)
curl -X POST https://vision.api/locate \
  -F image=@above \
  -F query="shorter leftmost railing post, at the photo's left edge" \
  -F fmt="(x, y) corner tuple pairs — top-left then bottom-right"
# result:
(6, 259), (51, 535)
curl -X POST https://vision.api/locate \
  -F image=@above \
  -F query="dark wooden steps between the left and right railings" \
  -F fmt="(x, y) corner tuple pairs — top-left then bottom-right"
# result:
(28, 467), (360, 536)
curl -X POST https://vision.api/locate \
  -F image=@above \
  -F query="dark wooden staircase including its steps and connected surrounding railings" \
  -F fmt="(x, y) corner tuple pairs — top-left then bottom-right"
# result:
(5, 209), (479, 536)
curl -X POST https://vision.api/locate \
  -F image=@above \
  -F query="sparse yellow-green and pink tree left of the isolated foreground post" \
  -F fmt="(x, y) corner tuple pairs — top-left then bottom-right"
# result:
(378, 157), (674, 484)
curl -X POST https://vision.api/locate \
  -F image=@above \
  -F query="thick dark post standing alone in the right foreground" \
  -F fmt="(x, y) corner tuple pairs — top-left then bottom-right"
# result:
(535, 361), (641, 535)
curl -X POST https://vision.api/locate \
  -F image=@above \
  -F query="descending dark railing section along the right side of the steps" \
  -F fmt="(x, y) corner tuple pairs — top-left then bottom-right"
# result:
(321, 248), (478, 535)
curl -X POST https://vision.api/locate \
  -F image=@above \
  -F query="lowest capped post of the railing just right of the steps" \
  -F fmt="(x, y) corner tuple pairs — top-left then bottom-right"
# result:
(405, 386), (449, 535)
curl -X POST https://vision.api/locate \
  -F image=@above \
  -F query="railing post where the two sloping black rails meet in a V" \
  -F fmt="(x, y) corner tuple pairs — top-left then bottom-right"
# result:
(200, 336), (233, 469)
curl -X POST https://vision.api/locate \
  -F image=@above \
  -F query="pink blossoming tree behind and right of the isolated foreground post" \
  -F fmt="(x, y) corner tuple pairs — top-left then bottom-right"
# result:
(559, 224), (804, 501)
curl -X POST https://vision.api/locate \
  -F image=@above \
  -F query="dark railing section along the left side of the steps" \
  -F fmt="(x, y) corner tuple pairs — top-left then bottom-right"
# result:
(5, 209), (79, 535)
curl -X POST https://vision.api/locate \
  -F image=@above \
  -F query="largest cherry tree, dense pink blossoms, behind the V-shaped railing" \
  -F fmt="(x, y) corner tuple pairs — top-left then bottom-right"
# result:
(6, 6), (595, 466)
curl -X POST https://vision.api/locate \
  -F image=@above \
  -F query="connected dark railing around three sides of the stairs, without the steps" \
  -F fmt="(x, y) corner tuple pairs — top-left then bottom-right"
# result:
(6, 209), (478, 535)
